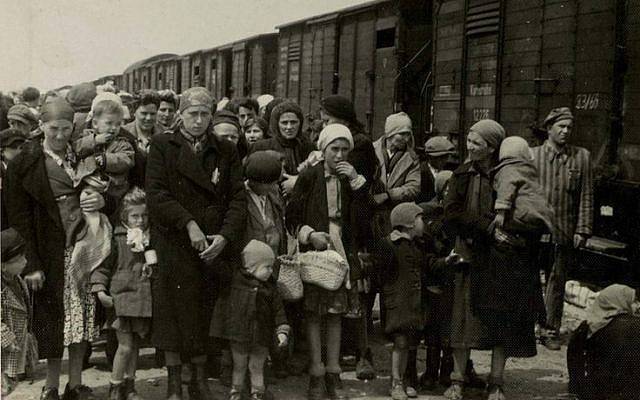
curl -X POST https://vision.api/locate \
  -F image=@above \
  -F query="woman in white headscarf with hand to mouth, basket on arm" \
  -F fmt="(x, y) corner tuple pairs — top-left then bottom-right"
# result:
(287, 124), (367, 399)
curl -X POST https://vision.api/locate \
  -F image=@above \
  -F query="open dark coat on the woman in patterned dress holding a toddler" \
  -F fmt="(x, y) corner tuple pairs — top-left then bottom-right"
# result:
(7, 142), (114, 358)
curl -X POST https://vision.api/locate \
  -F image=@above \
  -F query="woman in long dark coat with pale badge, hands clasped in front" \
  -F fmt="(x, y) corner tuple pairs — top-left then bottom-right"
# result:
(146, 87), (246, 400)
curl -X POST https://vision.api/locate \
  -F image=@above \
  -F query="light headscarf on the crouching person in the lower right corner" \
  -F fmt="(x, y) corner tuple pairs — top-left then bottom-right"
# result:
(587, 284), (636, 338)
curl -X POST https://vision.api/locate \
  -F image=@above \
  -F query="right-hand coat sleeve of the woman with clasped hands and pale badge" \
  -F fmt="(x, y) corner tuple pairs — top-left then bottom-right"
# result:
(220, 150), (247, 241)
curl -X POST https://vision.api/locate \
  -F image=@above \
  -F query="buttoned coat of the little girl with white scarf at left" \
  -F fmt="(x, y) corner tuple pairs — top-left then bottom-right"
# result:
(91, 226), (151, 318)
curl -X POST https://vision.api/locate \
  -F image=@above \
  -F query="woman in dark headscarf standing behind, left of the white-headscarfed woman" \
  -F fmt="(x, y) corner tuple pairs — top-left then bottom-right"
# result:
(250, 100), (314, 195)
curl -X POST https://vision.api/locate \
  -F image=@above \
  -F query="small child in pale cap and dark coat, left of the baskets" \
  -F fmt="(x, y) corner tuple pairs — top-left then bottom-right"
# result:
(211, 240), (290, 400)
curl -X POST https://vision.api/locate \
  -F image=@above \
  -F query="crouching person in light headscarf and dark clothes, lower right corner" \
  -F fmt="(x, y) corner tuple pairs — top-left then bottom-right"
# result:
(567, 285), (640, 400)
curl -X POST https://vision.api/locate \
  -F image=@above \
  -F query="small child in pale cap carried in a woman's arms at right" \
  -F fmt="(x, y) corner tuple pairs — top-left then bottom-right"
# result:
(493, 136), (553, 238)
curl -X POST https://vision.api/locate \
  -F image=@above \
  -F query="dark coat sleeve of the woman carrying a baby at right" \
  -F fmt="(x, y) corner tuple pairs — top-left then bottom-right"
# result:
(444, 174), (493, 237)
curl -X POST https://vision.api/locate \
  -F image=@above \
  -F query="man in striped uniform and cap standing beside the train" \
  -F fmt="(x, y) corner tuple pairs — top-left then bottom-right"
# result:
(533, 107), (593, 350)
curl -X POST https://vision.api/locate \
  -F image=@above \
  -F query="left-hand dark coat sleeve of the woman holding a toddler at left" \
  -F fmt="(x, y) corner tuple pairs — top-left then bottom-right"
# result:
(6, 159), (42, 277)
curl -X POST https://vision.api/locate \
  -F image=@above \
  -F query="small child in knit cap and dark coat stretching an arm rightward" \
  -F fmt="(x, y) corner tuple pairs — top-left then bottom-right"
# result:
(376, 203), (457, 400)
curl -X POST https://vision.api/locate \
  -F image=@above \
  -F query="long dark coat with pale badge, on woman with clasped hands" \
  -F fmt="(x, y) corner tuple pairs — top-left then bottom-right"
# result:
(146, 128), (246, 356)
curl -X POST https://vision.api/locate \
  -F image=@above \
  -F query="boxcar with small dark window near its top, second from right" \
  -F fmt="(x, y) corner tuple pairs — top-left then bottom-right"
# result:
(276, 0), (432, 142)
